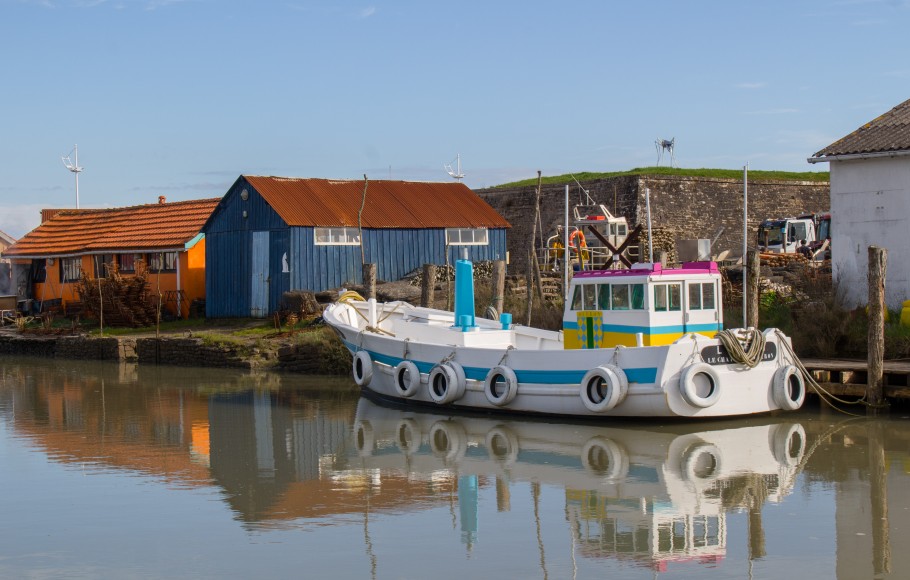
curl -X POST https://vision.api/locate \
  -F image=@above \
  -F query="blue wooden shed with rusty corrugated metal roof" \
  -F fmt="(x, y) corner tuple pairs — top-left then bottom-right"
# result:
(203, 175), (511, 317)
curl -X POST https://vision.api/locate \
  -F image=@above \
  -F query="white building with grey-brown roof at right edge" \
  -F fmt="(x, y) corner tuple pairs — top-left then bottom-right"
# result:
(808, 100), (910, 309)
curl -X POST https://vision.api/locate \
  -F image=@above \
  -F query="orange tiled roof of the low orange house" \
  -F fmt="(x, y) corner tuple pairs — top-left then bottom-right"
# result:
(3, 198), (221, 258)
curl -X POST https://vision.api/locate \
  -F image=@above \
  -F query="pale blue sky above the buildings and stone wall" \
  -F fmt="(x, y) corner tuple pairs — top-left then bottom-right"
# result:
(0, 0), (910, 238)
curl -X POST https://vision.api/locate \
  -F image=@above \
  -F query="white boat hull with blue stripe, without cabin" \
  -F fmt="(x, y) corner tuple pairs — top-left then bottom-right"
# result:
(324, 302), (805, 417)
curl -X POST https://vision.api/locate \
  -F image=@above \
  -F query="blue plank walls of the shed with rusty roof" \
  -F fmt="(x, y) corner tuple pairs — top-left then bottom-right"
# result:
(203, 177), (506, 318)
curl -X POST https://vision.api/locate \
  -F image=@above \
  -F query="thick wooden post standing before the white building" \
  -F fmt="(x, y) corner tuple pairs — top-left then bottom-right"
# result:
(866, 246), (888, 414)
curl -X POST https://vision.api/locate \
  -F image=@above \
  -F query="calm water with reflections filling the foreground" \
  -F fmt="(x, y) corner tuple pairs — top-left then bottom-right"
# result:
(0, 357), (910, 580)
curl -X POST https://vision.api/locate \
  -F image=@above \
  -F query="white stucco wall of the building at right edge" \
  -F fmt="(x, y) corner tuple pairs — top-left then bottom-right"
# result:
(830, 156), (910, 309)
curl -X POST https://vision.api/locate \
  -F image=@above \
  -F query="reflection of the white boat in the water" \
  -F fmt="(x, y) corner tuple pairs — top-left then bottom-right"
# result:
(354, 398), (806, 570)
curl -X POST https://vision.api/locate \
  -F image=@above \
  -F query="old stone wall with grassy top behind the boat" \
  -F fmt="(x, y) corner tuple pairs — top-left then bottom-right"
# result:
(476, 175), (830, 274)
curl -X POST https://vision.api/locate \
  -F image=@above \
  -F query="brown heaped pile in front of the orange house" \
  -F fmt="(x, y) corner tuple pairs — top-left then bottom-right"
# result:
(76, 266), (157, 328)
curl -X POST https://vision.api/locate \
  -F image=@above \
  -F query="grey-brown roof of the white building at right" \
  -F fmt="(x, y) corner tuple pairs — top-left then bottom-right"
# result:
(810, 100), (910, 161)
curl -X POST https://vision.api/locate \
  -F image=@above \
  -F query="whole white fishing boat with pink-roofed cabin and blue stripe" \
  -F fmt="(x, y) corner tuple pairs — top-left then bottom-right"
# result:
(323, 259), (806, 418)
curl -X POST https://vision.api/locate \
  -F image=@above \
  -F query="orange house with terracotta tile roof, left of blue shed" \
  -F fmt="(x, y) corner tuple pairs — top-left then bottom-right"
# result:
(2, 196), (219, 317)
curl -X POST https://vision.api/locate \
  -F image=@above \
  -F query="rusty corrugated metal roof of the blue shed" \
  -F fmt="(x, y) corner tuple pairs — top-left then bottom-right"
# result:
(243, 175), (511, 229)
